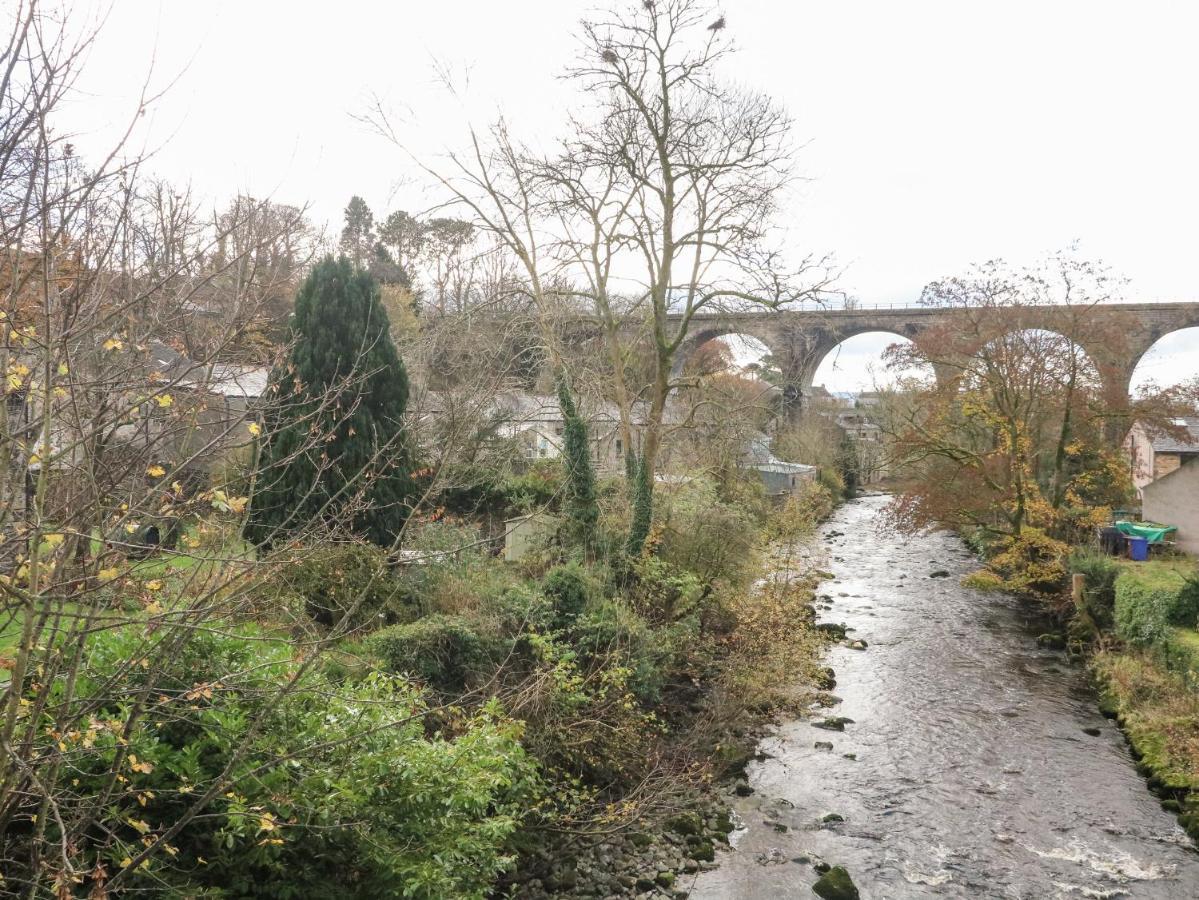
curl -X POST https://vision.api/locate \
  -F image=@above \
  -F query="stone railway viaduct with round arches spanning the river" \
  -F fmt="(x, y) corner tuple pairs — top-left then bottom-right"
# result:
(671, 302), (1199, 401)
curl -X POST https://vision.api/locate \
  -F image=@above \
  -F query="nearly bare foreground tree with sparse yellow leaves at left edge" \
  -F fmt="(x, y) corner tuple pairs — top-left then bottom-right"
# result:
(0, 2), (436, 896)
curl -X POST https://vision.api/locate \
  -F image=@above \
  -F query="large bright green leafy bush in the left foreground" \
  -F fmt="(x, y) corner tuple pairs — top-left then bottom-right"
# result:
(18, 626), (537, 900)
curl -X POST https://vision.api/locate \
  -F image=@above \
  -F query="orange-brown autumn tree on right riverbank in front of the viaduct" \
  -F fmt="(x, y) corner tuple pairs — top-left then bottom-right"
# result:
(887, 254), (1188, 538)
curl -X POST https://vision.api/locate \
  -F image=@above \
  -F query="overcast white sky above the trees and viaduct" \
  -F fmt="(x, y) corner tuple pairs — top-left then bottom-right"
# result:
(70, 0), (1199, 389)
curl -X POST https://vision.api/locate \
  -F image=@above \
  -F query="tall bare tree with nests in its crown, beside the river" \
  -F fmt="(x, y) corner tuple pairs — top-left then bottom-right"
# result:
(368, 0), (827, 550)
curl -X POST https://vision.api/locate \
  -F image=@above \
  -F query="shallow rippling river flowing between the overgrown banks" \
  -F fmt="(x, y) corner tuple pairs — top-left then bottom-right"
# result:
(680, 496), (1199, 900)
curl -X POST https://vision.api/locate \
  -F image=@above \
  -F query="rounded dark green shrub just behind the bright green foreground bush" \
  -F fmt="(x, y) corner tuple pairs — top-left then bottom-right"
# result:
(367, 614), (489, 693)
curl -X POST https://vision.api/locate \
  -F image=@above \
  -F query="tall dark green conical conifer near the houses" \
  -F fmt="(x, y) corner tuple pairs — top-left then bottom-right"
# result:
(246, 256), (414, 546)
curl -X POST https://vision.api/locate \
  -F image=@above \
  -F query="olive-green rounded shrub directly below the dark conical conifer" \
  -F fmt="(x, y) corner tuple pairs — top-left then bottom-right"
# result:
(269, 544), (412, 632)
